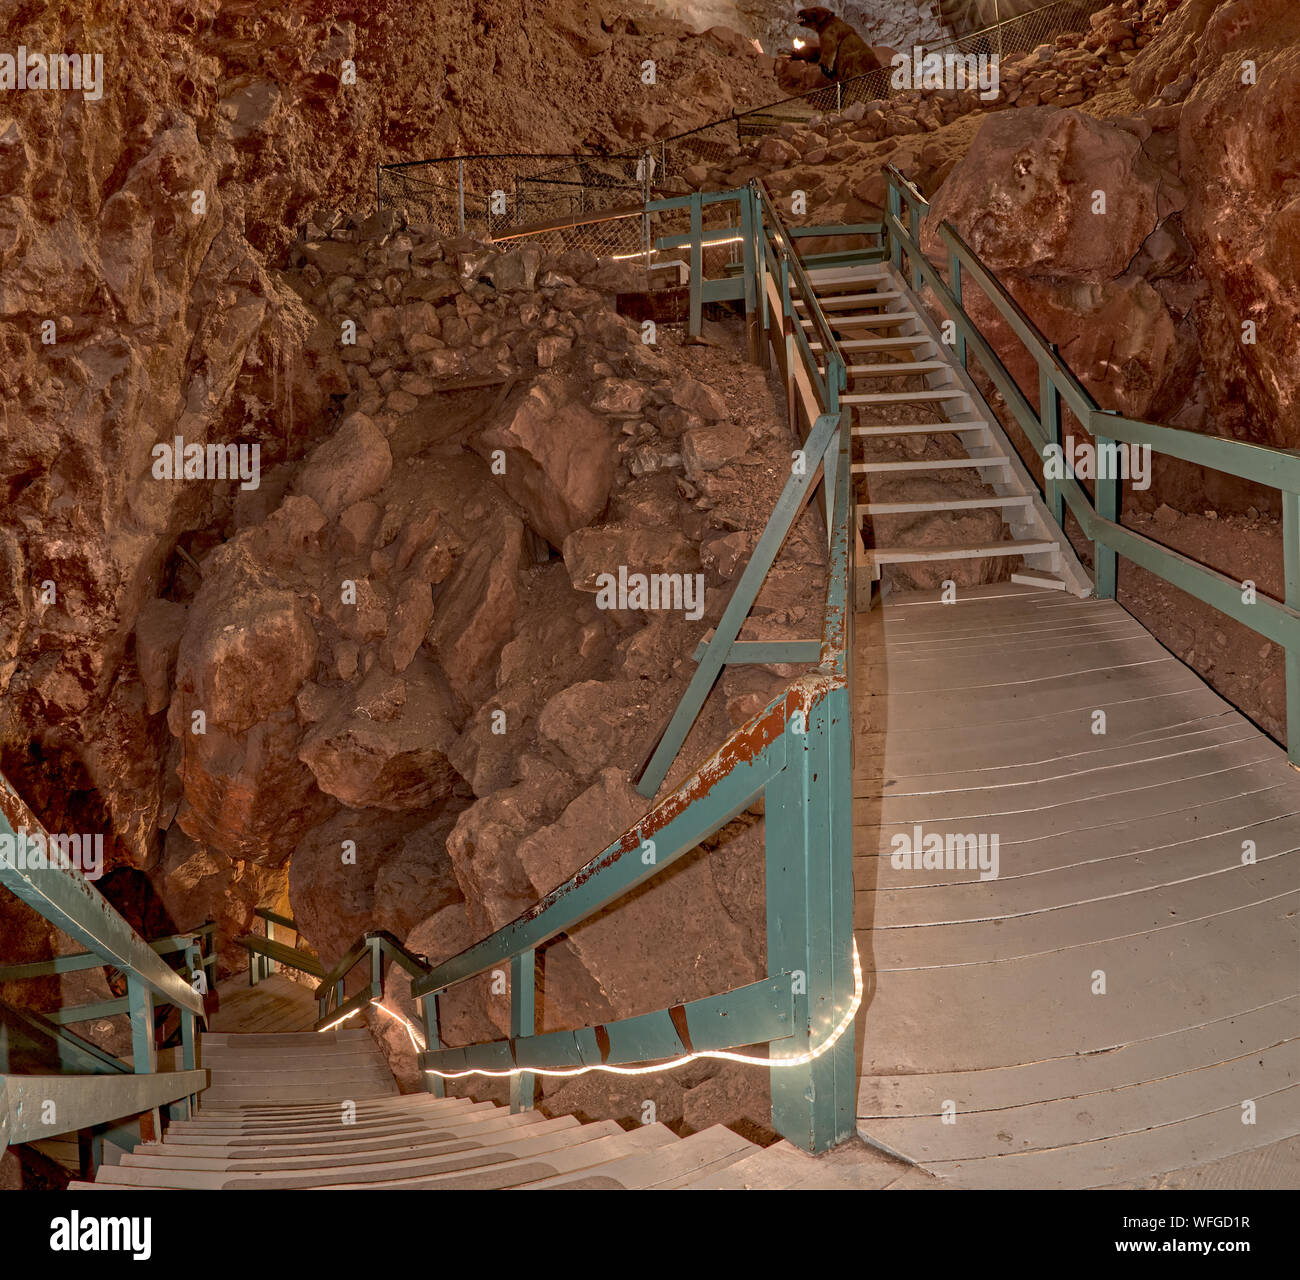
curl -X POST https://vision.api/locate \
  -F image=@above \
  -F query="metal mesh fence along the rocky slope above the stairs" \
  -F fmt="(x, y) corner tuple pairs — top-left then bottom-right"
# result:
(376, 0), (1093, 257)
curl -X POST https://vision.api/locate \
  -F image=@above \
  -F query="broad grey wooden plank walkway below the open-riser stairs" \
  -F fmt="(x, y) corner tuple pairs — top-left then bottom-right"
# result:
(854, 583), (1300, 1188)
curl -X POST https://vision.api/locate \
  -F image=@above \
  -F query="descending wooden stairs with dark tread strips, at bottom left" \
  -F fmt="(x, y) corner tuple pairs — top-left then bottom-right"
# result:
(72, 1029), (933, 1190)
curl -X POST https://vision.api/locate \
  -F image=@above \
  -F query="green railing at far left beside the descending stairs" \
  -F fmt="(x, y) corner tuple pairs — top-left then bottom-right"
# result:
(0, 777), (213, 1150)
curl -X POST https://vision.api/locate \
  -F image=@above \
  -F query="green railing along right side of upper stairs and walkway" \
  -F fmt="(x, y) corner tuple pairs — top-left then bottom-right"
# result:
(885, 159), (1300, 765)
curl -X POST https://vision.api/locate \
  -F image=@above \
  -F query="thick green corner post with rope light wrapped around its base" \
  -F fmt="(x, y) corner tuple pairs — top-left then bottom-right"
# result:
(766, 685), (857, 1151)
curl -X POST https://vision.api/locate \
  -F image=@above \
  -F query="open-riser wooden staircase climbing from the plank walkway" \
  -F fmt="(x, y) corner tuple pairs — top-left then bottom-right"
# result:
(797, 262), (1089, 595)
